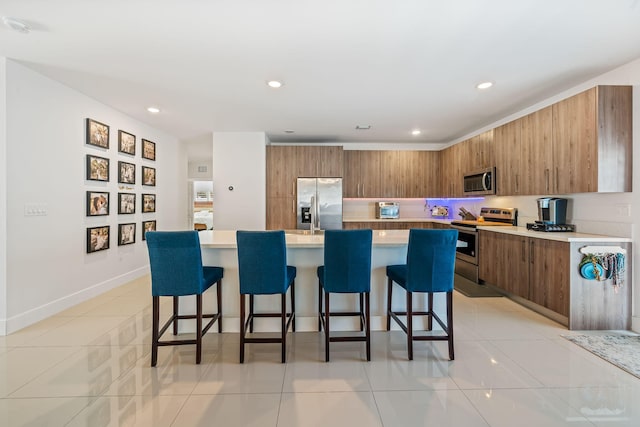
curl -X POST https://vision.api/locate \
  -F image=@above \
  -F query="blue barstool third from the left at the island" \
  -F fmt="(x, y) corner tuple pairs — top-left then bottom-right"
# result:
(317, 230), (372, 362)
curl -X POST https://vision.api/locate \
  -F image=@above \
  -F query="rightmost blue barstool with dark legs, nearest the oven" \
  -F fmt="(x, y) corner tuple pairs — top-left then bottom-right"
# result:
(387, 229), (458, 360)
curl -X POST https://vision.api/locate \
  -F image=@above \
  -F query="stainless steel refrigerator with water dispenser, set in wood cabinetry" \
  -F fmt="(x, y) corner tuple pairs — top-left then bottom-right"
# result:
(296, 178), (342, 230)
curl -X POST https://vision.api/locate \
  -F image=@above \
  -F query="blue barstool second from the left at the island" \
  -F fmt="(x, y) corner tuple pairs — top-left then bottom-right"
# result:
(236, 230), (296, 363)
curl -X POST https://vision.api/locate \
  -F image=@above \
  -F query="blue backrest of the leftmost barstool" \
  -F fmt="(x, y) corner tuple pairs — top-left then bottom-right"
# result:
(145, 231), (204, 296)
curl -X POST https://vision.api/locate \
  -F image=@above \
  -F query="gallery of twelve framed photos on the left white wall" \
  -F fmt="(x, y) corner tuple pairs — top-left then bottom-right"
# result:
(84, 118), (157, 253)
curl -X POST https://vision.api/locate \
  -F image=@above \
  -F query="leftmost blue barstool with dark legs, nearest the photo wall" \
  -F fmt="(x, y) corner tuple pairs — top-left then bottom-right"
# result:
(145, 231), (224, 366)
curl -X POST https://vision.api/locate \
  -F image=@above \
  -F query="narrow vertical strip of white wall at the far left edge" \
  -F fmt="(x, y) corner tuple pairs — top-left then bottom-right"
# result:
(0, 56), (7, 335)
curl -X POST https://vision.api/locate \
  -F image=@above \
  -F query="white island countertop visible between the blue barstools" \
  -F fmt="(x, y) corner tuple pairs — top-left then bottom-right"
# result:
(198, 230), (409, 249)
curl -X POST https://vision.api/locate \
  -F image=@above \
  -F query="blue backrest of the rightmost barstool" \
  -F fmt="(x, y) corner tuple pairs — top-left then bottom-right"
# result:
(406, 228), (458, 292)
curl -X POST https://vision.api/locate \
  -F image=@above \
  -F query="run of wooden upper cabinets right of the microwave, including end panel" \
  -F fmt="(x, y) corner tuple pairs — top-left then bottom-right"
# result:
(494, 86), (632, 196)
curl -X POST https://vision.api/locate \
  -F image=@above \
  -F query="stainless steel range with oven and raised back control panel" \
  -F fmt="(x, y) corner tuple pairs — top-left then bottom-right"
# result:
(451, 208), (518, 283)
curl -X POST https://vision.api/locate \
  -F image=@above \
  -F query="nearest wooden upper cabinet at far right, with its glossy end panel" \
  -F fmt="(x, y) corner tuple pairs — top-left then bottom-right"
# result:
(553, 86), (632, 194)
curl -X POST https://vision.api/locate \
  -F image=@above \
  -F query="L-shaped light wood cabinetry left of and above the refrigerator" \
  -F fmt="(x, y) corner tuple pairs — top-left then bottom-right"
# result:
(266, 145), (343, 230)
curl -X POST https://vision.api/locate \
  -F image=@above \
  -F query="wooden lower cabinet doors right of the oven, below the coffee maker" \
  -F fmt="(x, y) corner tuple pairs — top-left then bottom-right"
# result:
(478, 230), (571, 317)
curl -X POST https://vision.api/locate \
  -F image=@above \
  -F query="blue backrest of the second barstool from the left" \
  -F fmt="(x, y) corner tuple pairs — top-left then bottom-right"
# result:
(236, 230), (288, 294)
